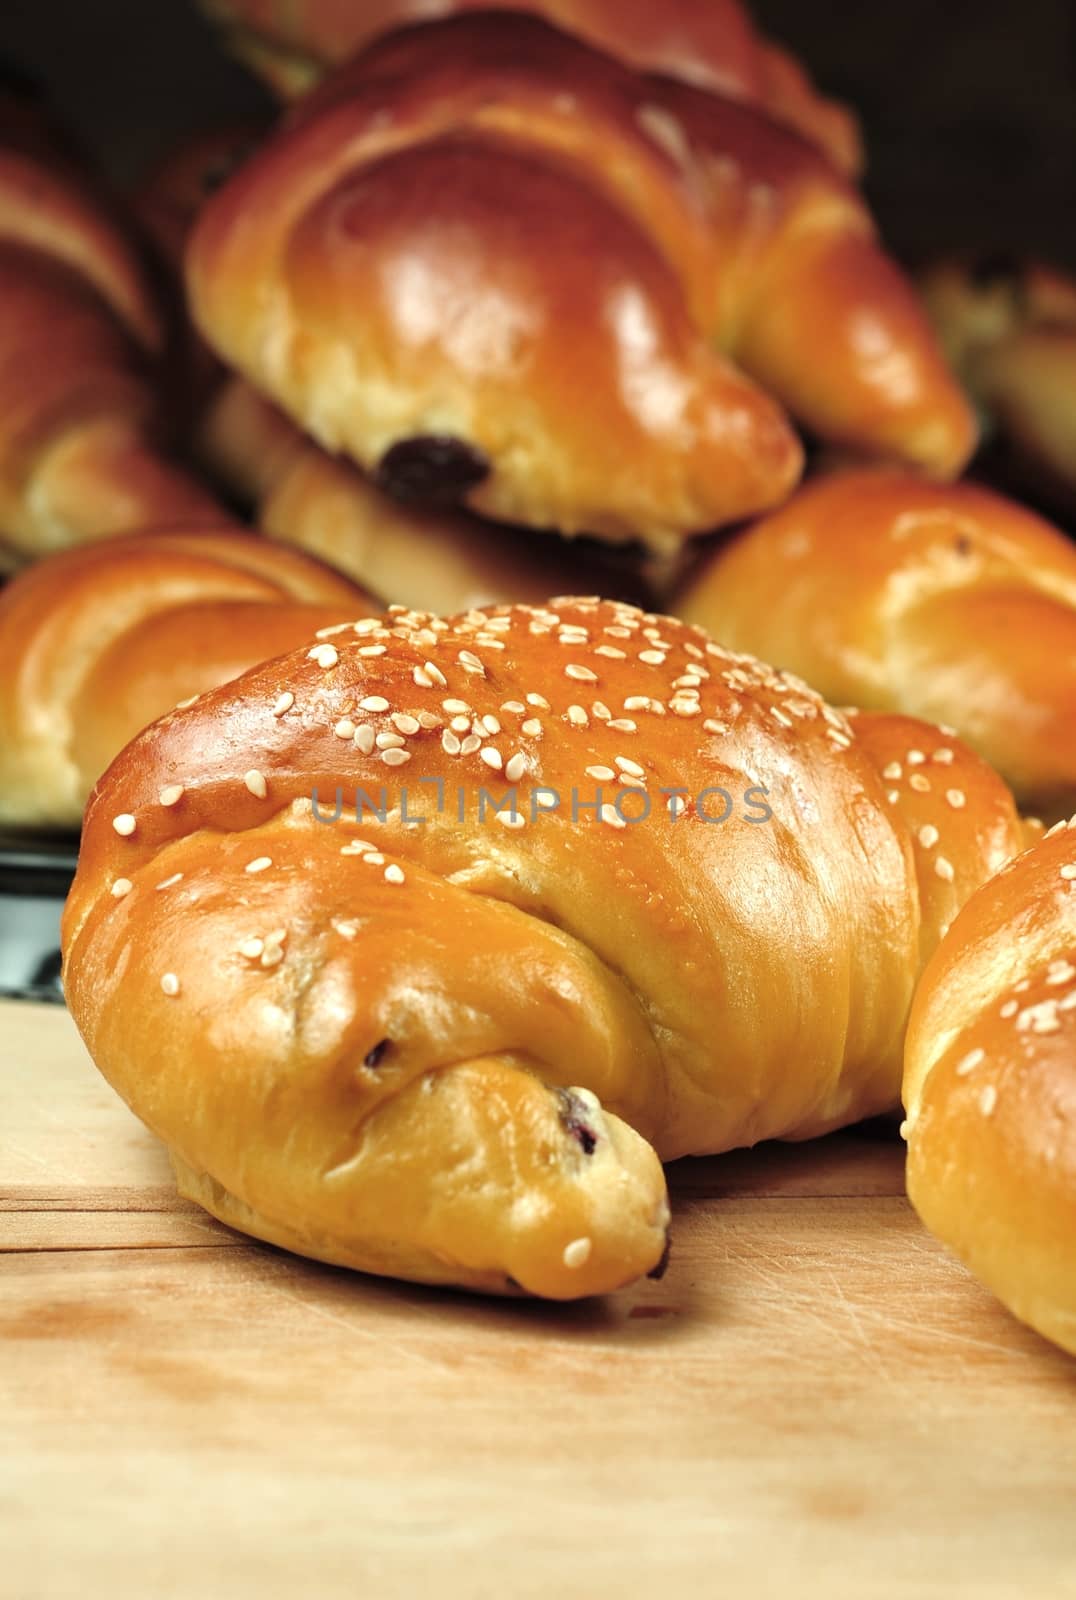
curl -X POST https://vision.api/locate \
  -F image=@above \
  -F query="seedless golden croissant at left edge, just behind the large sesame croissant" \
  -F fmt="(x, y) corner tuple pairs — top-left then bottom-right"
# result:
(0, 526), (368, 827)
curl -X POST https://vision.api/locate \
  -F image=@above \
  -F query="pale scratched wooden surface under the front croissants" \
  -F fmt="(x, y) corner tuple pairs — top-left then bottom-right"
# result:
(0, 1005), (1076, 1600)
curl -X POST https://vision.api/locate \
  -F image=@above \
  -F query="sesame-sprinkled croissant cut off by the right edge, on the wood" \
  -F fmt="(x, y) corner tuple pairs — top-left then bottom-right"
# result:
(905, 824), (1076, 1354)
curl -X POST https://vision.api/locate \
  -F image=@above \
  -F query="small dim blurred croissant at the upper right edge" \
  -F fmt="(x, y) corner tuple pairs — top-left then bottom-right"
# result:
(922, 256), (1076, 514)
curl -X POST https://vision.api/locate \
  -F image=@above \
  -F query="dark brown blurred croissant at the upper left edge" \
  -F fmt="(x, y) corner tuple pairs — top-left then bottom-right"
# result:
(0, 93), (219, 565)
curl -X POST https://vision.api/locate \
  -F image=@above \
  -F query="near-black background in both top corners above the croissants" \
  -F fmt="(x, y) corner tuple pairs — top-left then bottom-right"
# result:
(0, 0), (1076, 267)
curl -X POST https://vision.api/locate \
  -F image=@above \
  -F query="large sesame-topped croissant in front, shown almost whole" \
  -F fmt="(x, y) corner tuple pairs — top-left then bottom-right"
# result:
(64, 598), (1023, 1299)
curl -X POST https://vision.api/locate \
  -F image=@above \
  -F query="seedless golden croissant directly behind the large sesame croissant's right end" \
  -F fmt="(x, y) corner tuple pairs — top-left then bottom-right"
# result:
(673, 472), (1076, 816)
